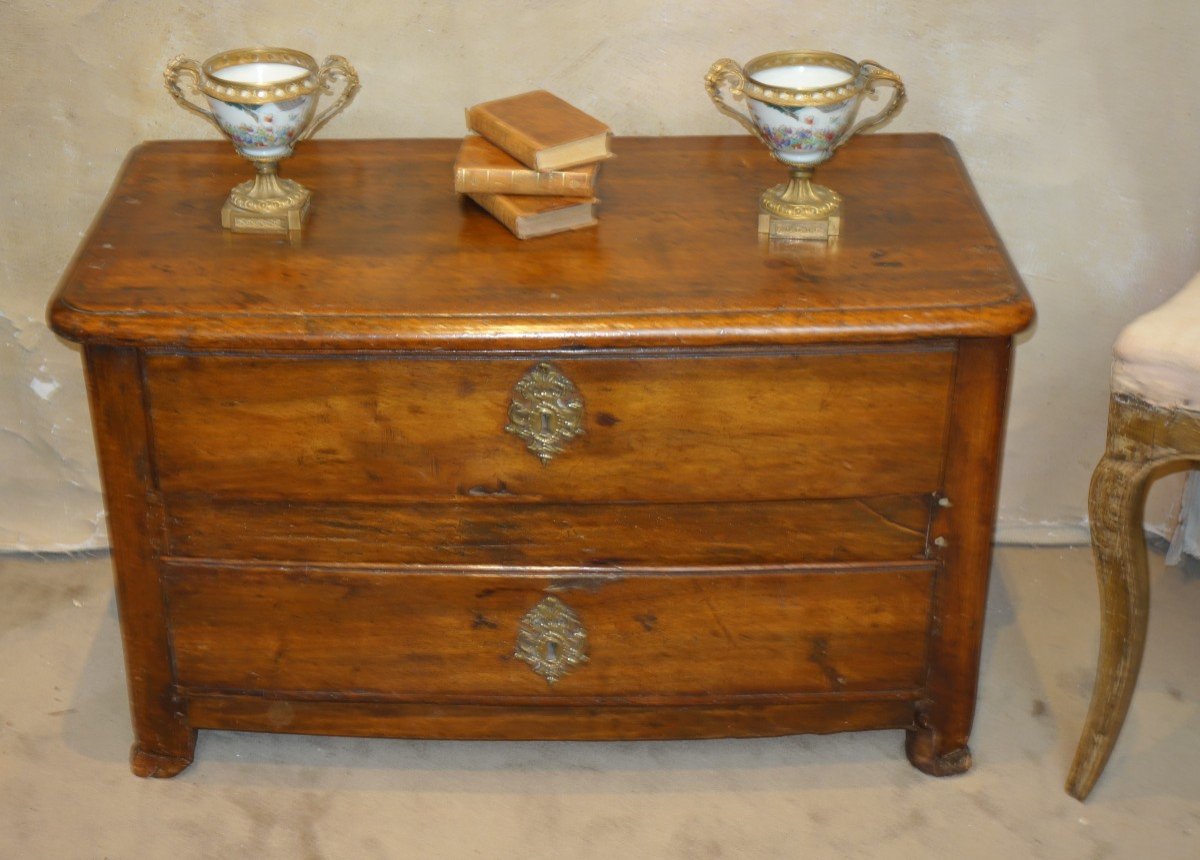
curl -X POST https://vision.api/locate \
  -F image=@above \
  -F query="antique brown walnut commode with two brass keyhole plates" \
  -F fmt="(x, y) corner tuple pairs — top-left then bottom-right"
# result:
(50, 136), (1032, 776)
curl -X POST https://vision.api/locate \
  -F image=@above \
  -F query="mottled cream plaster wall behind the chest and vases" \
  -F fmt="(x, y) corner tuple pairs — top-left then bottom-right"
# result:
(0, 0), (1200, 549)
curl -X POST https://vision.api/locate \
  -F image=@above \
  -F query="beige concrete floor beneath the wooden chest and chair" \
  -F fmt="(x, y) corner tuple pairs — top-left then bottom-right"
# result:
(0, 547), (1200, 860)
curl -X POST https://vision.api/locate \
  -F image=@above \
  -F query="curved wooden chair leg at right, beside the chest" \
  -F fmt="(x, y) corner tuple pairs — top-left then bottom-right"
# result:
(1067, 444), (1151, 800)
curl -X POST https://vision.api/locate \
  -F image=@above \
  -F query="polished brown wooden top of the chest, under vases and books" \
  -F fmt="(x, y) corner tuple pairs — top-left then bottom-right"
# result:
(50, 134), (1033, 351)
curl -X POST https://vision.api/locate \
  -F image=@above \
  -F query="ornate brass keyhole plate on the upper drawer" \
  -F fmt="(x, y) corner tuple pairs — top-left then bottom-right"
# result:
(504, 361), (583, 463)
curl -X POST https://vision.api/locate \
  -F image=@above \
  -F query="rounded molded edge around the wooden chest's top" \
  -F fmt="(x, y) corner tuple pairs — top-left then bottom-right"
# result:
(47, 133), (1034, 353)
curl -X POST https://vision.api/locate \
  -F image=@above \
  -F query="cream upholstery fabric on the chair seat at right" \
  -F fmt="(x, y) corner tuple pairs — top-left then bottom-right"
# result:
(1112, 275), (1200, 411)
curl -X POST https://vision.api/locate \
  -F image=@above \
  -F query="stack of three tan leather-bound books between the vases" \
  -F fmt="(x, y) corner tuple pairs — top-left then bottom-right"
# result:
(454, 90), (612, 239)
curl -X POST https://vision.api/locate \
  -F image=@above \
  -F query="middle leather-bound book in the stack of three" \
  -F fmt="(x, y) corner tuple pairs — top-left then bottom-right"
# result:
(454, 134), (600, 197)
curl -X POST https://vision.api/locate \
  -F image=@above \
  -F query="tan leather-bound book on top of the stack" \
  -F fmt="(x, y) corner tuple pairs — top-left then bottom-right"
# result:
(467, 90), (612, 170)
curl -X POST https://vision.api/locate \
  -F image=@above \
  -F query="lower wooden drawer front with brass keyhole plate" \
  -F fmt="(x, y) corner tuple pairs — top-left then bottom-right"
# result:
(166, 565), (932, 704)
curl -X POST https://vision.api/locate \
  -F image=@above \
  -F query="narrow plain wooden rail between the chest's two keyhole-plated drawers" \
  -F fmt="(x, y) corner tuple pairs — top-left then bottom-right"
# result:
(166, 493), (932, 569)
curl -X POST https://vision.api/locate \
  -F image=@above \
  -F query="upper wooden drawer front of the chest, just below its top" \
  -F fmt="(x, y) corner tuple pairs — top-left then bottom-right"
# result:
(145, 348), (954, 503)
